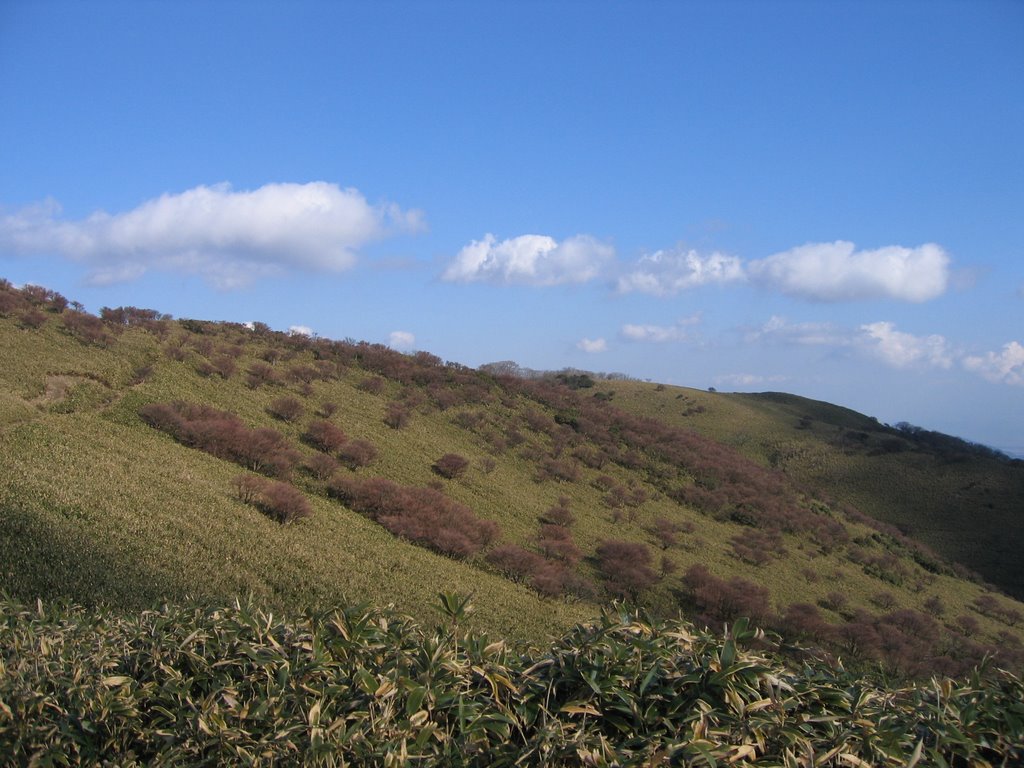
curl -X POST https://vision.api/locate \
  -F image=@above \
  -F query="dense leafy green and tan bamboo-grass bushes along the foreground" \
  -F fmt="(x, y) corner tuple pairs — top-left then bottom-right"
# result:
(0, 595), (1024, 766)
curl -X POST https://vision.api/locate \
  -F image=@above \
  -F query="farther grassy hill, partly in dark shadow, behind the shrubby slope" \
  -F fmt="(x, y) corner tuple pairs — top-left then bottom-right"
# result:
(606, 382), (1024, 598)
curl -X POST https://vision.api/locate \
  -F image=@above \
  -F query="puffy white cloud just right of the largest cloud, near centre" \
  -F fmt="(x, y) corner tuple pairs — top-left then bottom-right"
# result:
(442, 233), (614, 286)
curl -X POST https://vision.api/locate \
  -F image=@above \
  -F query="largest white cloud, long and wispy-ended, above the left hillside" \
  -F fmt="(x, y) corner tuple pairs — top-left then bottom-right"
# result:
(0, 181), (422, 289)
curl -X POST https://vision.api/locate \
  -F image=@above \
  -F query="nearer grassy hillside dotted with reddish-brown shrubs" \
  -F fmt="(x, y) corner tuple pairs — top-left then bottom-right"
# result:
(0, 278), (1024, 676)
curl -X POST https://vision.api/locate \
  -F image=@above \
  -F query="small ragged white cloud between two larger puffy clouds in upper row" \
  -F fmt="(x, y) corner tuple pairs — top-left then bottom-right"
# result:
(617, 251), (743, 296)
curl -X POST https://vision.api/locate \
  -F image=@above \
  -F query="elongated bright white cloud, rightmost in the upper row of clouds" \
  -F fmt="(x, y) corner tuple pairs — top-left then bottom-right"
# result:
(746, 241), (949, 302)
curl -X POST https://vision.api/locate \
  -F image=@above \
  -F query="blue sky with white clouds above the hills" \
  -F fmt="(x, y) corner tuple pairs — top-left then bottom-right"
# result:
(0, 0), (1024, 454)
